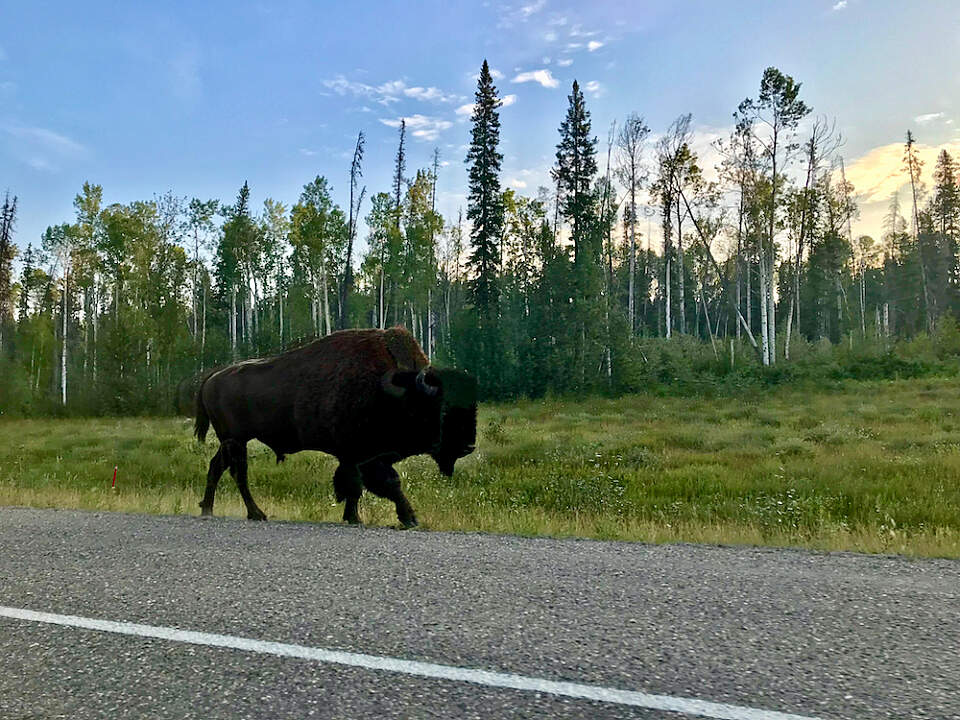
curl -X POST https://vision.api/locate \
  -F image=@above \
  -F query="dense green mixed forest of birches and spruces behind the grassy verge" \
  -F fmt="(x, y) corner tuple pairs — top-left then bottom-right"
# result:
(0, 62), (960, 413)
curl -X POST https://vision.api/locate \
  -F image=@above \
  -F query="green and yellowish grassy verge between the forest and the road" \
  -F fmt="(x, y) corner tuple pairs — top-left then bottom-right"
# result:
(0, 379), (960, 557)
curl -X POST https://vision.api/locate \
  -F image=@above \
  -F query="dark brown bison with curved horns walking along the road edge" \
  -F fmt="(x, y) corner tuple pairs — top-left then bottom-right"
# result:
(195, 328), (477, 527)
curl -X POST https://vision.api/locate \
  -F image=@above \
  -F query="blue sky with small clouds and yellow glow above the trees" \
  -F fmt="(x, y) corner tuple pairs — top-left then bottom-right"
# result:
(0, 0), (960, 264)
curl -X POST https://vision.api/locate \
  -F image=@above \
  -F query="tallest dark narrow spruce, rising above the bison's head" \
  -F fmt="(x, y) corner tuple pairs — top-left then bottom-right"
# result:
(466, 60), (503, 324)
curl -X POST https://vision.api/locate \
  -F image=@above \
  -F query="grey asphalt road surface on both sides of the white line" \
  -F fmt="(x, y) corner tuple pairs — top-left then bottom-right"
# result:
(0, 508), (960, 720)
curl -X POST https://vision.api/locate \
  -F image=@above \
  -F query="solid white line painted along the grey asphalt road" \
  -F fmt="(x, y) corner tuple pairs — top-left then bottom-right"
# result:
(0, 605), (818, 720)
